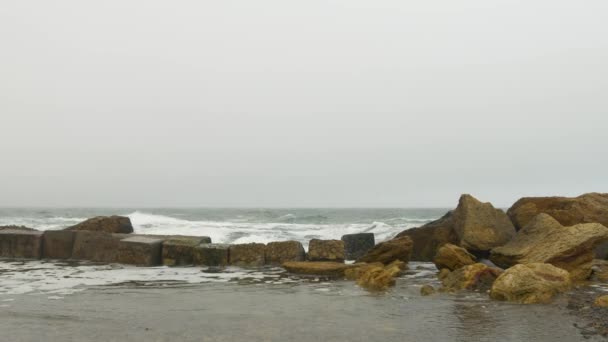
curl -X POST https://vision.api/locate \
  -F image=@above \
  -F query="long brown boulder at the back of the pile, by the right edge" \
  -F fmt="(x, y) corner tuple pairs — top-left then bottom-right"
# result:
(507, 193), (608, 230)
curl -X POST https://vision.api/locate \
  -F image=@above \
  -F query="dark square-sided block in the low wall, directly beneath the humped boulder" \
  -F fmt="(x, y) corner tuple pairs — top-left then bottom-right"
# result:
(72, 230), (129, 263)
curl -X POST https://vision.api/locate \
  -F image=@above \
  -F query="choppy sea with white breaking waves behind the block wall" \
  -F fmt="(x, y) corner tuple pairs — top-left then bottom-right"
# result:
(0, 208), (448, 247)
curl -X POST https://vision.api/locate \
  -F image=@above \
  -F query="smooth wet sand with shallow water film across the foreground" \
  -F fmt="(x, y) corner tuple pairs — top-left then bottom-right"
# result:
(0, 264), (603, 341)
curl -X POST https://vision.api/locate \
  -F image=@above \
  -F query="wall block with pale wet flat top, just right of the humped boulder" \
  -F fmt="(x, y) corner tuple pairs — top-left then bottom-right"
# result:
(116, 236), (163, 266)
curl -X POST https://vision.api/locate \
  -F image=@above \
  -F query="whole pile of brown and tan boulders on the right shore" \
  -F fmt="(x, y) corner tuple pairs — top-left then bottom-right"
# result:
(397, 193), (608, 305)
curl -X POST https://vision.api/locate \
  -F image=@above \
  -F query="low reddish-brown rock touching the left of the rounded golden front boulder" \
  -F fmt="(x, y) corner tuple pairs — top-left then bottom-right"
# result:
(441, 263), (502, 291)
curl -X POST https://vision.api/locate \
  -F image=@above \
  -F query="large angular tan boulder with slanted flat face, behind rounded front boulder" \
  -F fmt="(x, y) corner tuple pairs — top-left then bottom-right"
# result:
(490, 214), (608, 280)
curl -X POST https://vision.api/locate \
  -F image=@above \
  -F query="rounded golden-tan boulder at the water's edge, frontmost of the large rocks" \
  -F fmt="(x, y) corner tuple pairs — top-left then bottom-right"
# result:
(490, 263), (572, 304)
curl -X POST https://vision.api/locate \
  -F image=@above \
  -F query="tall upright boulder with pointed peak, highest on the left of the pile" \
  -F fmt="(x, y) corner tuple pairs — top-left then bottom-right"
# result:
(454, 195), (515, 252)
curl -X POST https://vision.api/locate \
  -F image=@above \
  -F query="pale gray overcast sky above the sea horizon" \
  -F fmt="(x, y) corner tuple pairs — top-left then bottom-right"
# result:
(0, 0), (608, 207)
